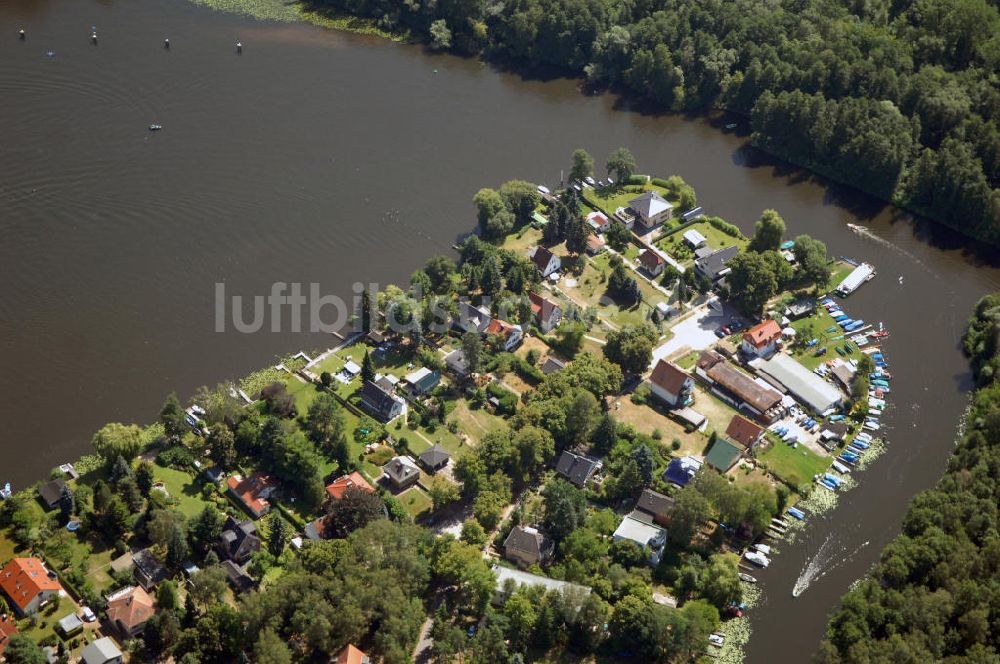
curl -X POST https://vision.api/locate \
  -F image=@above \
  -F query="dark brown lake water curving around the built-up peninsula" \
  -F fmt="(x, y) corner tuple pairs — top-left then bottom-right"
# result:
(0, 0), (1000, 662)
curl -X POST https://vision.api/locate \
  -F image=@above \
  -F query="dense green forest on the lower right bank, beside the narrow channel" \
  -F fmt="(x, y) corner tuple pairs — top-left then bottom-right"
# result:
(817, 294), (1000, 664)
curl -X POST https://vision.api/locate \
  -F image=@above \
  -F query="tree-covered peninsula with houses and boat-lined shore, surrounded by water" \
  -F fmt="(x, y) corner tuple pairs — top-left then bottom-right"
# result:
(0, 148), (892, 664)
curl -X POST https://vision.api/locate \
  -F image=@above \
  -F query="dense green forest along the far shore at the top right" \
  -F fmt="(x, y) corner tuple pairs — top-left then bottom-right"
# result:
(311, 0), (1000, 244)
